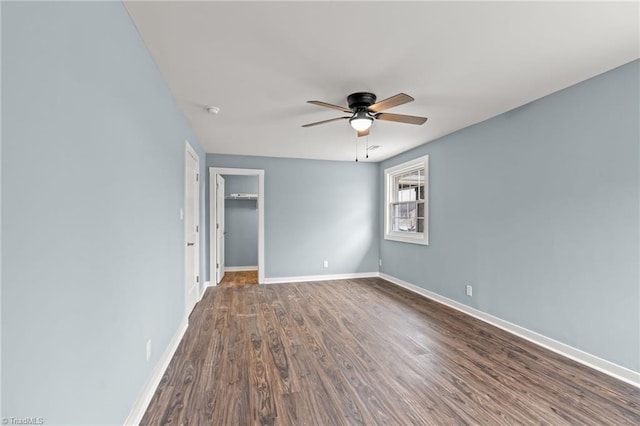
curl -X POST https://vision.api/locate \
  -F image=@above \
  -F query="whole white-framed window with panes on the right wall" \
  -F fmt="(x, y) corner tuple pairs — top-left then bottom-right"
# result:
(384, 155), (429, 245)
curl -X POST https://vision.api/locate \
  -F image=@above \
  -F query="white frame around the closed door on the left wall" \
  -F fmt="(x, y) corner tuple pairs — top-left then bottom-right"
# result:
(181, 140), (202, 317)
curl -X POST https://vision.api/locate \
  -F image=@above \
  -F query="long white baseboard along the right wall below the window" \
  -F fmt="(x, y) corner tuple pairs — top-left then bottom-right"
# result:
(380, 273), (640, 387)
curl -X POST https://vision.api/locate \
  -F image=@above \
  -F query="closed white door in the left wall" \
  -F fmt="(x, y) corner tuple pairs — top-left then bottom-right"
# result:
(184, 145), (200, 316)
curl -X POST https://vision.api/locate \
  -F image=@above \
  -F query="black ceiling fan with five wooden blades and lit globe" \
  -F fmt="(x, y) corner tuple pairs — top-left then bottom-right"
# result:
(302, 92), (427, 136)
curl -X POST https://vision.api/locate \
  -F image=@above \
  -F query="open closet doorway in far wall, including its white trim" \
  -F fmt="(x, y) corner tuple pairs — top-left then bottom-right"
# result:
(209, 167), (264, 285)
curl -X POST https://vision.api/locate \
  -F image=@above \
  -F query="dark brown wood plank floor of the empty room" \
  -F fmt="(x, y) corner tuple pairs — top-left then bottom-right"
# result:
(141, 278), (640, 425)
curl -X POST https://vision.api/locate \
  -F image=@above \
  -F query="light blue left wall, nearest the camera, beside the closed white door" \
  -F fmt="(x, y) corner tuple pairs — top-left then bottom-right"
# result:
(1, 2), (204, 425)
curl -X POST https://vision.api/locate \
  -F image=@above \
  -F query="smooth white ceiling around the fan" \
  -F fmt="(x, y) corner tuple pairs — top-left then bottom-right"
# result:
(125, 1), (640, 161)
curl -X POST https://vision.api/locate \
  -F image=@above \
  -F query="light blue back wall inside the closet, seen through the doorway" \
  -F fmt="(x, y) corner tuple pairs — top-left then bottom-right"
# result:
(224, 175), (258, 267)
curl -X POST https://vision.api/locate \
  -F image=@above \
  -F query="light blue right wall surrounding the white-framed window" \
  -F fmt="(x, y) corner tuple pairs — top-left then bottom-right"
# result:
(378, 61), (640, 371)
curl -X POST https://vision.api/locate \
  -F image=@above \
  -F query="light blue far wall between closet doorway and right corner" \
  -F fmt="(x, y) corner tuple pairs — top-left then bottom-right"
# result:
(207, 154), (380, 278)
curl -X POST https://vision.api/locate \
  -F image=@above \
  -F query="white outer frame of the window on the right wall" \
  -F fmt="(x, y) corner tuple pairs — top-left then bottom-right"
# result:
(384, 155), (429, 245)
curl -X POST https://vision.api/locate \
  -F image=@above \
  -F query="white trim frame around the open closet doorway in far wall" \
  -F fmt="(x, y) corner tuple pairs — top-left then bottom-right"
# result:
(209, 167), (264, 284)
